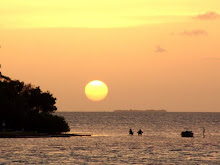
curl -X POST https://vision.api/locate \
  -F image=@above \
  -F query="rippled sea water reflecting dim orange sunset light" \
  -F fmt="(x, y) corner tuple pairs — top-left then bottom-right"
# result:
(0, 112), (220, 165)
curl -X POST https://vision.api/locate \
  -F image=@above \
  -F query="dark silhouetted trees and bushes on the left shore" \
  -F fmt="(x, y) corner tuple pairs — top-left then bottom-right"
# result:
(0, 75), (69, 133)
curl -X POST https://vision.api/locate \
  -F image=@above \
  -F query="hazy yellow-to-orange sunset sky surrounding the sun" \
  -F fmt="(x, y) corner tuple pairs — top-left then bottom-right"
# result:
(0, 0), (220, 112)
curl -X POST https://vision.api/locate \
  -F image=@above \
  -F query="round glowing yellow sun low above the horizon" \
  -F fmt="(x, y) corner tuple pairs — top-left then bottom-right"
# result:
(85, 80), (108, 101)
